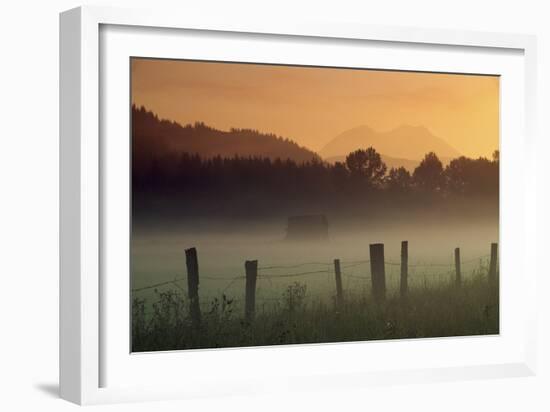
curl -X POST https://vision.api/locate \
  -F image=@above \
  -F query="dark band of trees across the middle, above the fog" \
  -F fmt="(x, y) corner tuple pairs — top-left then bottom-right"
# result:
(133, 147), (499, 197)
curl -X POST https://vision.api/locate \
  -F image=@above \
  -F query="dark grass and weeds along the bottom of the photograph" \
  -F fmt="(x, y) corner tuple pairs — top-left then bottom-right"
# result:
(132, 275), (499, 352)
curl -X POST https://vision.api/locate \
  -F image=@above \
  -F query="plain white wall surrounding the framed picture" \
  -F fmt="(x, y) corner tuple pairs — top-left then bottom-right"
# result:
(0, 0), (550, 412)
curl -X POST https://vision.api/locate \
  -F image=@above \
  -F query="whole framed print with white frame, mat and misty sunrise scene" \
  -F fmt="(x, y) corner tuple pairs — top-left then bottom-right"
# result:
(60, 8), (536, 403)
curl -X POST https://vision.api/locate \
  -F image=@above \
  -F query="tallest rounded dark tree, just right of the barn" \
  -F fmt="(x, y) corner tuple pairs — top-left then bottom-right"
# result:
(346, 147), (387, 187)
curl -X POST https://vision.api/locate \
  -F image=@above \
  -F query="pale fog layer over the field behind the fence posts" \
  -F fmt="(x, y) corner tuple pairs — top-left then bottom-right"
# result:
(132, 217), (498, 308)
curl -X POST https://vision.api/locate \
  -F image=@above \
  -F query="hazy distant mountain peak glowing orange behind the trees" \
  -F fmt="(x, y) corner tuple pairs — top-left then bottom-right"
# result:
(319, 125), (460, 161)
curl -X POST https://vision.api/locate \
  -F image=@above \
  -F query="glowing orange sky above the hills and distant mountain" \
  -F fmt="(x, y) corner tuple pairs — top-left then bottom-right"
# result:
(131, 58), (499, 157)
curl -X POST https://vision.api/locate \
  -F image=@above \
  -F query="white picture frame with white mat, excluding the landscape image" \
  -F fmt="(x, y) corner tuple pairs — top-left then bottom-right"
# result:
(60, 7), (537, 404)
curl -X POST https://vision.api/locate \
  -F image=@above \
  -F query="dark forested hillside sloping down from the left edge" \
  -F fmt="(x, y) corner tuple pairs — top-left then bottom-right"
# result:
(132, 106), (320, 167)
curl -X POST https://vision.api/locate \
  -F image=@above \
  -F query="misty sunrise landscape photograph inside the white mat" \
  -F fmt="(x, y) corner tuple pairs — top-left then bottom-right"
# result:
(132, 57), (500, 352)
